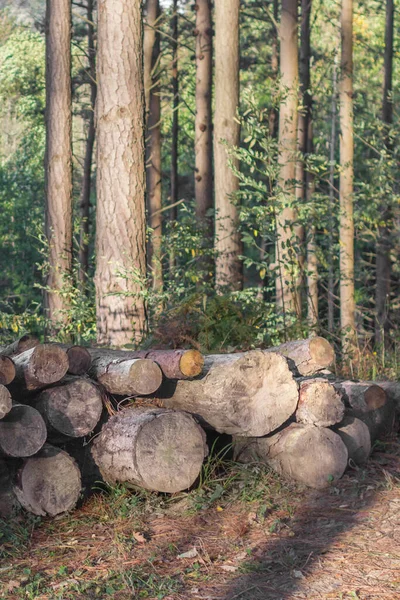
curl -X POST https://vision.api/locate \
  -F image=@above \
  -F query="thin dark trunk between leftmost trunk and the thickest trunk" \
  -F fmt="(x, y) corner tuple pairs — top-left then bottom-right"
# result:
(79, 0), (97, 284)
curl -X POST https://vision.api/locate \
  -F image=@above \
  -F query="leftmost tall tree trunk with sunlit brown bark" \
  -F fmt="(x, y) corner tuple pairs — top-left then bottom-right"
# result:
(45, 0), (72, 328)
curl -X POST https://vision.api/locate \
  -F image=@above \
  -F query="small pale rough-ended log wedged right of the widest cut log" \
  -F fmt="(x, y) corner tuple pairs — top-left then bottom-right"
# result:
(296, 378), (345, 427)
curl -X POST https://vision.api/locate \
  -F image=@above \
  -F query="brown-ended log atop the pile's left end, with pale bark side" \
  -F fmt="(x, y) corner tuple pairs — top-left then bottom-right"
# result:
(12, 344), (68, 391)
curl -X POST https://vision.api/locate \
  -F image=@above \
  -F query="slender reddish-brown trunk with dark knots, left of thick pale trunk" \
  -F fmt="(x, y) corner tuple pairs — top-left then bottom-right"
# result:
(194, 0), (213, 246)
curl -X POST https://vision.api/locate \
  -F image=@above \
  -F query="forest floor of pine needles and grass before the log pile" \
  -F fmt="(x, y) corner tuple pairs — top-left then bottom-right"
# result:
(0, 438), (400, 600)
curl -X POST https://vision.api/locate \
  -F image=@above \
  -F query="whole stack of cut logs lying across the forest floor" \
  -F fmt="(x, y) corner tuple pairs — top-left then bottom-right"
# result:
(0, 336), (400, 516)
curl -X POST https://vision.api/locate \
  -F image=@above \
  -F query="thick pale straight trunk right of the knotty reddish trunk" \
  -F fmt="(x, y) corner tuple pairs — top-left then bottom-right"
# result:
(214, 0), (243, 290)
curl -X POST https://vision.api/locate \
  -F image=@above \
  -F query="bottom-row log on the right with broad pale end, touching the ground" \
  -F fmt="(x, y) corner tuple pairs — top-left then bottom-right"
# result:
(234, 423), (348, 489)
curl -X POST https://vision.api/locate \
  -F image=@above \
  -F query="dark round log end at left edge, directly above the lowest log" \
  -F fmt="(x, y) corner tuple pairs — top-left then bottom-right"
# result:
(0, 404), (47, 458)
